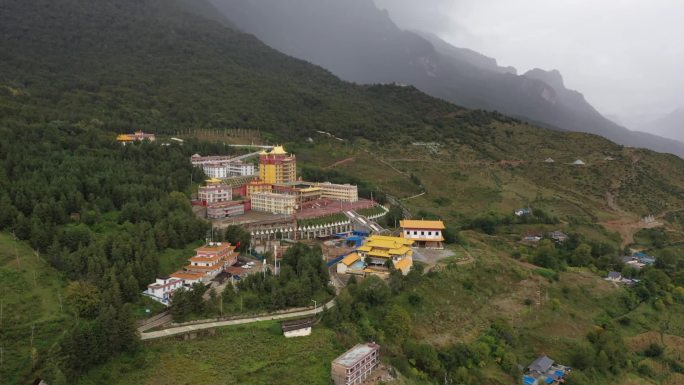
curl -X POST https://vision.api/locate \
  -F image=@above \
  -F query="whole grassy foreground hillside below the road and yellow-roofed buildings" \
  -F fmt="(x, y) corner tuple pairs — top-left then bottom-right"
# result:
(80, 233), (684, 385)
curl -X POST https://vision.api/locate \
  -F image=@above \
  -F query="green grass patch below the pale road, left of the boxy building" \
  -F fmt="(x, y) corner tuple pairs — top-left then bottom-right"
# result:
(79, 322), (344, 385)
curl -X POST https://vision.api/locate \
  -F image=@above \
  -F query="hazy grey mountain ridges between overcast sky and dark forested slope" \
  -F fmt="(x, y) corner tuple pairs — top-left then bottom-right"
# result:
(212, 0), (684, 156)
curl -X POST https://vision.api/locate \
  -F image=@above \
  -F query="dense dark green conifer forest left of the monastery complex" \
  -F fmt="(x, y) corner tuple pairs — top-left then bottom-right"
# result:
(0, 123), (209, 380)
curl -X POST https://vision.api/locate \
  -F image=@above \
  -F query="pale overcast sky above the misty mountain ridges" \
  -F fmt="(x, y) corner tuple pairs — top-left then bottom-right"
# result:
(375, 0), (684, 125)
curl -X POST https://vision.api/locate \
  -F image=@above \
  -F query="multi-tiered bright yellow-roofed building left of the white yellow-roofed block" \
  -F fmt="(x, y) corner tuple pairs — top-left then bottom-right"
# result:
(356, 235), (413, 275)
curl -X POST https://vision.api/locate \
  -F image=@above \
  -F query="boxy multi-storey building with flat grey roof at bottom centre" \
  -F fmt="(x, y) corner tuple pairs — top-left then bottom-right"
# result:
(330, 343), (380, 385)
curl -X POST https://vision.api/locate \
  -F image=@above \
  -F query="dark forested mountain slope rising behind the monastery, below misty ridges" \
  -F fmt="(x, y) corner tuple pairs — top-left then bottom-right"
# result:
(0, 0), (684, 213)
